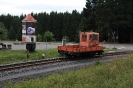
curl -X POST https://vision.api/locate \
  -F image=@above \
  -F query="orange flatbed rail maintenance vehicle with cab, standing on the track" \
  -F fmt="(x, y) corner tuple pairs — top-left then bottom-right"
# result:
(58, 32), (103, 57)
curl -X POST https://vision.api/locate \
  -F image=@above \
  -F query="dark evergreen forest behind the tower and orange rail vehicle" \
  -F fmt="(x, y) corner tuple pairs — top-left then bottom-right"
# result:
(0, 0), (133, 43)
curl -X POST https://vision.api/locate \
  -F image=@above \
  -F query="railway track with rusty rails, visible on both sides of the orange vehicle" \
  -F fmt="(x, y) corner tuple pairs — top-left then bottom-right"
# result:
(0, 51), (132, 72)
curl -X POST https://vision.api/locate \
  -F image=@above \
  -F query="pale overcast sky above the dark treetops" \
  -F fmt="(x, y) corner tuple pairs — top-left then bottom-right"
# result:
(0, 0), (86, 16)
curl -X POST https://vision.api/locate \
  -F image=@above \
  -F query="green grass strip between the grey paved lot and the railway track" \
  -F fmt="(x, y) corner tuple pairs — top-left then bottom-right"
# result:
(0, 49), (60, 64)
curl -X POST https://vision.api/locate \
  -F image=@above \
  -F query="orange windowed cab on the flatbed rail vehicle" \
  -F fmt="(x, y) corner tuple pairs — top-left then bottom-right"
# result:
(79, 32), (99, 47)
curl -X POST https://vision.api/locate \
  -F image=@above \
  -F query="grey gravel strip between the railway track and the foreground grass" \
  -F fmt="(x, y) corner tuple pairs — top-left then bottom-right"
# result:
(0, 55), (127, 88)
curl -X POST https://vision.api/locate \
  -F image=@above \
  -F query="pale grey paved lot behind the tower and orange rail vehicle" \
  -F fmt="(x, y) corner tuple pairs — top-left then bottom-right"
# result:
(3, 42), (133, 51)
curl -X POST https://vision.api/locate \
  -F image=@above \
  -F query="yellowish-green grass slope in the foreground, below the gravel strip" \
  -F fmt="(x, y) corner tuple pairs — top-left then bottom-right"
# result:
(6, 55), (133, 88)
